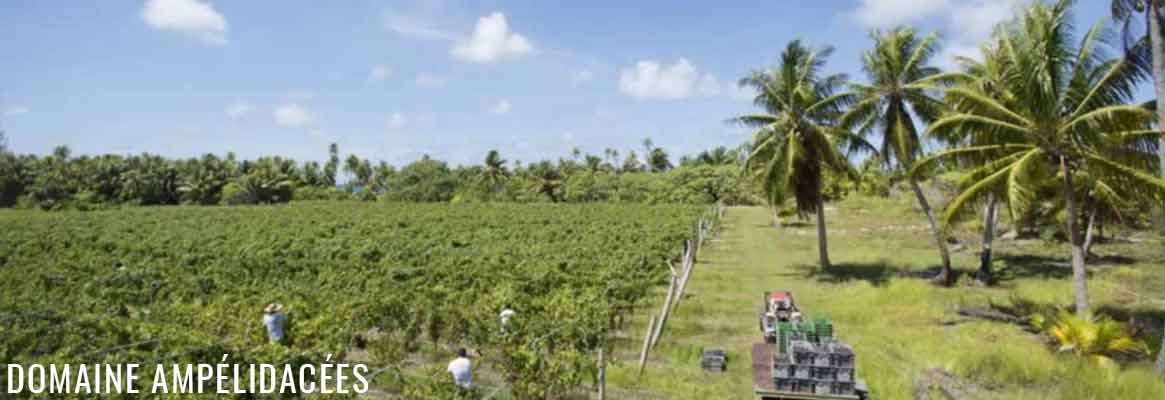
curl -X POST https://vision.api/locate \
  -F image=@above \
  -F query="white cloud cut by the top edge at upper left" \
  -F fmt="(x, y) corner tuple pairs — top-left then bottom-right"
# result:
(141, 0), (227, 44)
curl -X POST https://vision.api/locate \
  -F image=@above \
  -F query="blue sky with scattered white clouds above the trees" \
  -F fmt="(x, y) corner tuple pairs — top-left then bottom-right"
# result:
(0, 0), (1108, 166)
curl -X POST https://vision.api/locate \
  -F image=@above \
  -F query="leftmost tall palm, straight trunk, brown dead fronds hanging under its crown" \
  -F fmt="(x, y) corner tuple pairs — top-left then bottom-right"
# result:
(730, 41), (861, 268)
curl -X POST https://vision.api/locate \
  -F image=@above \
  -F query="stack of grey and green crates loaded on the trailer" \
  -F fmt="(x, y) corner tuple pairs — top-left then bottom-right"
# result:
(772, 320), (854, 395)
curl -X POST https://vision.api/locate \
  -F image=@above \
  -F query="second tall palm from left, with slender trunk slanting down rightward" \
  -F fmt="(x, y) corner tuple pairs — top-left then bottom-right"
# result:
(841, 28), (953, 285)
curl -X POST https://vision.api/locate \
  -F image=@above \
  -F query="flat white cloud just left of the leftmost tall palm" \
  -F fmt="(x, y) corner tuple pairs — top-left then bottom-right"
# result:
(619, 58), (701, 100)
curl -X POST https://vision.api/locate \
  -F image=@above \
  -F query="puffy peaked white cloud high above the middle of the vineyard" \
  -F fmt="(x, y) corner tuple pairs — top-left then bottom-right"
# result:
(450, 12), (534, 63)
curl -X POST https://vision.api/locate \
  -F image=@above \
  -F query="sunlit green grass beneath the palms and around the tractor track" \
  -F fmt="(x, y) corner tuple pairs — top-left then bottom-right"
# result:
(608, 198), (1165, 399)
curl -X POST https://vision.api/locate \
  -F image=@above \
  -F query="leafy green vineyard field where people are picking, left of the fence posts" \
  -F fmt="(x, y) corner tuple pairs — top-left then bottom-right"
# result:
(0, 202), (714, 398)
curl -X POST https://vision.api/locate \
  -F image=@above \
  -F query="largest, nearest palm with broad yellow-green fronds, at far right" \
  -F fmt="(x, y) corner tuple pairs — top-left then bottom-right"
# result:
(911, 0), (1165, 315)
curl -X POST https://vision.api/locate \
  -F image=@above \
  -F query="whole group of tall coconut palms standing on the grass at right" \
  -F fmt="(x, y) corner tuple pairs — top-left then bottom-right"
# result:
(732, 0), (1165, 321)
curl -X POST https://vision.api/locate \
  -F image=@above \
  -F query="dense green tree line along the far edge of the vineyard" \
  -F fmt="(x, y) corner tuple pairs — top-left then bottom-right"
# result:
(0, 134), (773, 210)
